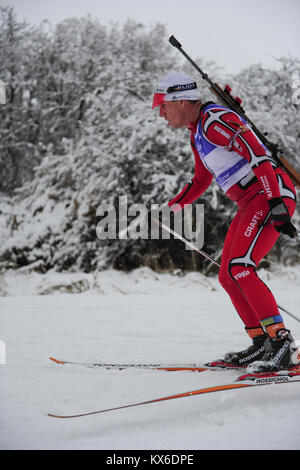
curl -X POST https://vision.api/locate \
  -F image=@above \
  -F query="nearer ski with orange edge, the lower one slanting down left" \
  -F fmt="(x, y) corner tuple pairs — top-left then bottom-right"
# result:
(48, 368), (300, 419)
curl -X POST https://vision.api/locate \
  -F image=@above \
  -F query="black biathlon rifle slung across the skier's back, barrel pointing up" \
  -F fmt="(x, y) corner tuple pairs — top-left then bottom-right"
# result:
(169, 36), (300, 188)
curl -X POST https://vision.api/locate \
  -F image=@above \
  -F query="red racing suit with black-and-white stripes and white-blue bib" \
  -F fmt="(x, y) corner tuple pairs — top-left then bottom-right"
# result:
(169, 103), (296, 328)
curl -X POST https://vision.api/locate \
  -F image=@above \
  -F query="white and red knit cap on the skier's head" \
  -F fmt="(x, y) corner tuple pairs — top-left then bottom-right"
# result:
(152, 72), (200, 108)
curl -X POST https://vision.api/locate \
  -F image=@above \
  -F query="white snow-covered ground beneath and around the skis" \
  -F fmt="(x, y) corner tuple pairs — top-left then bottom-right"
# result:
(0, 268), (300, 450)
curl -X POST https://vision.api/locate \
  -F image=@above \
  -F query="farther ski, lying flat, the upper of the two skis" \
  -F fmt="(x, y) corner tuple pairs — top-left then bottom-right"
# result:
(49, 357), (244, 372)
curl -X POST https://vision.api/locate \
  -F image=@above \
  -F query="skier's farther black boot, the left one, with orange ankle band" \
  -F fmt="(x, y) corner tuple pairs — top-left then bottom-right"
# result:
(222, 327), (270, 367)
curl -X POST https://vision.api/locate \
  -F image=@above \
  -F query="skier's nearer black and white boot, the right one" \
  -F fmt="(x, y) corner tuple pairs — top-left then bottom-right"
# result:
(247, 328), (300, 373)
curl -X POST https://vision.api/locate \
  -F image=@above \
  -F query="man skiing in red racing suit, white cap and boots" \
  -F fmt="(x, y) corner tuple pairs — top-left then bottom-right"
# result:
(152, 73), (300, 372)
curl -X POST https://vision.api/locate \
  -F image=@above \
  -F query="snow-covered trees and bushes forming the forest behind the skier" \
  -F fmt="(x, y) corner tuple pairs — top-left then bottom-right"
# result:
(0, 7), (300, 280)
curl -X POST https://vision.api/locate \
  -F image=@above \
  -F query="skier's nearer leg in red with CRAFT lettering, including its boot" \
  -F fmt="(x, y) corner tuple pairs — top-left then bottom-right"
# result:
(229, 184), (300, 371)
